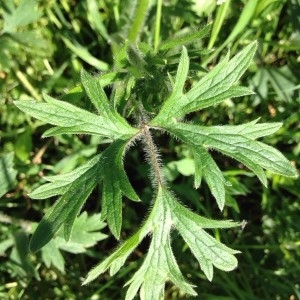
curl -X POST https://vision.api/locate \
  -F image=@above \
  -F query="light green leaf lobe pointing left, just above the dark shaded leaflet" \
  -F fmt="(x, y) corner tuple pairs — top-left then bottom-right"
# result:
(14, 95), (137, 139)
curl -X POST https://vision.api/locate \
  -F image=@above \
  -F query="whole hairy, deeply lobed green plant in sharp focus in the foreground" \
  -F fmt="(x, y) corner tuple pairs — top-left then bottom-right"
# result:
(15, 40), (297, 300)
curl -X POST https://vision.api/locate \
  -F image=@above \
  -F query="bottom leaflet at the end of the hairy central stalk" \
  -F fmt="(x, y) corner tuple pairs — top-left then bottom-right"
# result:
(83, 187), (240, 300)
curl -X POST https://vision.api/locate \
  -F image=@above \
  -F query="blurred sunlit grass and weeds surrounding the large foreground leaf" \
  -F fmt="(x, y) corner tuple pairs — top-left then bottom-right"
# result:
(0, 0), (300, 300)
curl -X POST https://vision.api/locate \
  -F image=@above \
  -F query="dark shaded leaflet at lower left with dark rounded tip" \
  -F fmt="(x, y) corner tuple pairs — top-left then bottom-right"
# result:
(30, 140), (139, 252)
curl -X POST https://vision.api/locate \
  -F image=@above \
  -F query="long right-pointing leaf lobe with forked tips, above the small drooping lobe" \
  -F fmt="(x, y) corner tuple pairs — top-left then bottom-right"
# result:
(165, 122), (297, 185)
